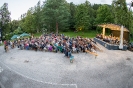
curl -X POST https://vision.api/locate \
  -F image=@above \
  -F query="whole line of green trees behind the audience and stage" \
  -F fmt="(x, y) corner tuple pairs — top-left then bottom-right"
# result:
(0, 0), (133, 40)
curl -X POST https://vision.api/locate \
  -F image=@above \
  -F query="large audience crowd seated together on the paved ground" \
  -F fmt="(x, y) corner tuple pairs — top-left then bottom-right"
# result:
(4, 33), (96, 57)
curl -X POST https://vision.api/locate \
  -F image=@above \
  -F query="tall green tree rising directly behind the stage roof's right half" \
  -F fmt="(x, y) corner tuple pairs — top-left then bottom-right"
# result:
(112, 0), (129, 28)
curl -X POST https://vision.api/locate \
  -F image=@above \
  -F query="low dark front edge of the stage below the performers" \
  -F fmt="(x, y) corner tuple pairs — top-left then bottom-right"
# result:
(94, 38), (127, 50)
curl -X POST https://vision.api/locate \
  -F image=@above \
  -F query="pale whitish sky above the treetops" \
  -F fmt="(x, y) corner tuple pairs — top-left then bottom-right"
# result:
(0, 0), (132, 20)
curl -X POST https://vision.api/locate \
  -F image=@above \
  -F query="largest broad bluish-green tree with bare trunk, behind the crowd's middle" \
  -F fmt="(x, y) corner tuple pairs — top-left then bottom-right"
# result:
(43, 0), (70, 33)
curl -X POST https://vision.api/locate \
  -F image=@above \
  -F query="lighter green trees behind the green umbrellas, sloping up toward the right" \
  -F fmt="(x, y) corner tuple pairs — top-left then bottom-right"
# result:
(19, 1), (43, 33)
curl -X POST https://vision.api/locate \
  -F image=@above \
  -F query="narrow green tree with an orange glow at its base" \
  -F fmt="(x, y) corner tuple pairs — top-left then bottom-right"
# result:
(75, 1), (91, 31)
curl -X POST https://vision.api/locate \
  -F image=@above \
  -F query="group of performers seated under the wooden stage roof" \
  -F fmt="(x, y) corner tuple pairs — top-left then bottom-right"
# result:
(96, 34), (127, 45)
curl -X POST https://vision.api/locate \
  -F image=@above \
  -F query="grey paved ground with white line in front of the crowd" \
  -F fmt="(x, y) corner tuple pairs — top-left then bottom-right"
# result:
(0, 45), (133, 88)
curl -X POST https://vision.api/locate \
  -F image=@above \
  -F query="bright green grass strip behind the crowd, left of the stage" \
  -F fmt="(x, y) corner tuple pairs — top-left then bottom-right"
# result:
(61, 31), (97, 38)
